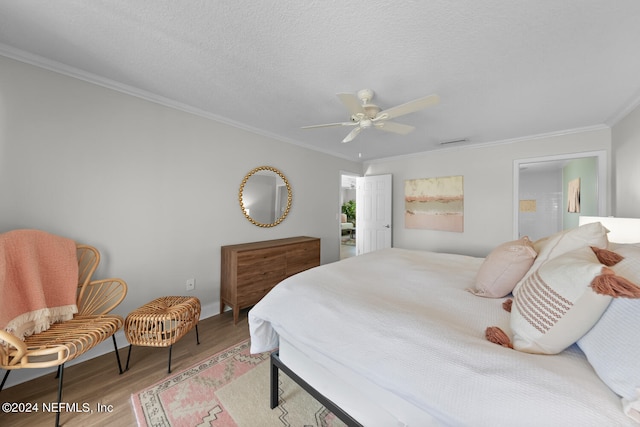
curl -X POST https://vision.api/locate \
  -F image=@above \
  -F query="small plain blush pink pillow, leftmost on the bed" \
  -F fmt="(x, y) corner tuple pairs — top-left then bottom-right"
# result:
(468, 236), (537, 298)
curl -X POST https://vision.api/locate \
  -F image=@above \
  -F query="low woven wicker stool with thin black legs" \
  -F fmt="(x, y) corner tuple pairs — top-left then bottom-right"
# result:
(124, 297), (200, 373)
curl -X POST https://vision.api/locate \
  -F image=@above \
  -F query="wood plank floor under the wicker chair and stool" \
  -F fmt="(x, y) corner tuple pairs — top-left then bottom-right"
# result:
(0, 310), (250, 427)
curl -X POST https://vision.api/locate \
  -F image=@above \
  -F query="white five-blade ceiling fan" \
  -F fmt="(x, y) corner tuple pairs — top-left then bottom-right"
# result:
(302, 89), (440, 143)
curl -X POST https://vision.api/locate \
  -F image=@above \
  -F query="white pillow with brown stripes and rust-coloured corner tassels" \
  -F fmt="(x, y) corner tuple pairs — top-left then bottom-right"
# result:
(486, 246), (640, 354)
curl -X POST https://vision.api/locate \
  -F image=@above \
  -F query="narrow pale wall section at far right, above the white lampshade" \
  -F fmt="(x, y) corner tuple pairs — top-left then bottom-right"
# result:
(612, 106), (640, 218)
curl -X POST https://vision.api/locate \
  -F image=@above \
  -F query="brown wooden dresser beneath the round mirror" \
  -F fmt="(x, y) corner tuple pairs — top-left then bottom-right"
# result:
(220, 236), (320, 323)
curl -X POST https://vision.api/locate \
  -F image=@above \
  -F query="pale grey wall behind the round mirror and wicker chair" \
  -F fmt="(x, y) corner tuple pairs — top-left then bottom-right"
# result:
(0, 57), (362, 386)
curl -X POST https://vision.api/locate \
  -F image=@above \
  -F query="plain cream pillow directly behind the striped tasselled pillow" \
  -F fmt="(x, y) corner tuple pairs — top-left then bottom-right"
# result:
(513, 222), (609, 295)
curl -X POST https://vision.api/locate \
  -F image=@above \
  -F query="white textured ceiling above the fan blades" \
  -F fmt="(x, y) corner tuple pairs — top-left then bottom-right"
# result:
(0, 0), (640, 160)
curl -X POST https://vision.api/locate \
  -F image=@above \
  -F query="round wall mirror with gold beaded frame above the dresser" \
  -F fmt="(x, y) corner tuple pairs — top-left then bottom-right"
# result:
(238, 166), (291, 227)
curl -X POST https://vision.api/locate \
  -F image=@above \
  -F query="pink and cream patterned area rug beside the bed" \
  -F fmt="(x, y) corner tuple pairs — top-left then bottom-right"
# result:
(131, 340), (344, 427)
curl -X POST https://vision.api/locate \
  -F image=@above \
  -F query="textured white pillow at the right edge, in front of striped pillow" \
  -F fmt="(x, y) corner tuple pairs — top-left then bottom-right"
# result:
(578, 245), (640, 422)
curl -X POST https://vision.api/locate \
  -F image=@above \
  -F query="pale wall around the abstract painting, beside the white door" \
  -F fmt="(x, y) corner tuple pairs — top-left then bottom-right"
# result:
(365, 127), (611, 256)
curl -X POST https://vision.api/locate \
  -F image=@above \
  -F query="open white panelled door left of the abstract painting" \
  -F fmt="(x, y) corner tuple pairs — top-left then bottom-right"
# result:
(356, 175), (391, 255)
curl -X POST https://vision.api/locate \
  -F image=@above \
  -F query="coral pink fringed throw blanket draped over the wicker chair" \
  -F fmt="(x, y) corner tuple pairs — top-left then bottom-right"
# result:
(0, 230), (78, 339)
